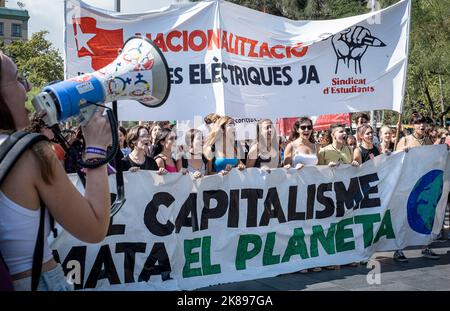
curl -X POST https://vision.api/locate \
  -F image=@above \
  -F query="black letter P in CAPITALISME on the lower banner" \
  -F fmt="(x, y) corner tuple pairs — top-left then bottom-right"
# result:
(200, 190), (228, 230)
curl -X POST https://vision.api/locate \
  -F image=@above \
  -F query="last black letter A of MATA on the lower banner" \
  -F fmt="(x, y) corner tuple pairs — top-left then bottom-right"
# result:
(138, 243), (172, 282)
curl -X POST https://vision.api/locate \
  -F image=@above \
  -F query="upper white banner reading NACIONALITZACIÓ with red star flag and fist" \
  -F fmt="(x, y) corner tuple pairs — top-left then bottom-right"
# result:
(65, 0), (411, 121)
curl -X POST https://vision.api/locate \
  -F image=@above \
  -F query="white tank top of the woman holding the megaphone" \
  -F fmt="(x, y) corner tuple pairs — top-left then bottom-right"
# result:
(0, 135), (52, 275)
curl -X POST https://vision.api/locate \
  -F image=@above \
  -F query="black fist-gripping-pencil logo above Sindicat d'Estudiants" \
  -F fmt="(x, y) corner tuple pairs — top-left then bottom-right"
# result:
(331, 26), (386, 74)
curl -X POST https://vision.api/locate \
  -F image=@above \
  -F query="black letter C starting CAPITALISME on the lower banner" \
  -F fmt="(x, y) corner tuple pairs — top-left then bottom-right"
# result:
(144, 192), (175, 236)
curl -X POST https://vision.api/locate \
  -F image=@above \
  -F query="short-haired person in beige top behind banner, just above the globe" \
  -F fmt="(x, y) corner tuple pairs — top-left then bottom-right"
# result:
(394, 113), (439, 262)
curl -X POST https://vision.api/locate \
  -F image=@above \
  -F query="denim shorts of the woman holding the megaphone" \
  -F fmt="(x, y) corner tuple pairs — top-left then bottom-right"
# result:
(13, 264), (73, 291)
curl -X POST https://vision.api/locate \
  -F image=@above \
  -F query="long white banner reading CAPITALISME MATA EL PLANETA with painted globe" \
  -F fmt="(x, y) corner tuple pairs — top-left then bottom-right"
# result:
(52, 145), (450, 290)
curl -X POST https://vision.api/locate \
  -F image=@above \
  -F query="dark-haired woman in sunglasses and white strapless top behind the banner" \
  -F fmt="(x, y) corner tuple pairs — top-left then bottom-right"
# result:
(284, 117), (319, 169)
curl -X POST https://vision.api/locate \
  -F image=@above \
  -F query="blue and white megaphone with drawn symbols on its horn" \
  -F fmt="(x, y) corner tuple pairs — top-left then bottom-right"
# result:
(32, 37), (170, 127)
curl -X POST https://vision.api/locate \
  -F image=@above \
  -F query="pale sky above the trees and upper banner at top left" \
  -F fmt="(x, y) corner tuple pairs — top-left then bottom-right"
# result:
(6, 0), (187, 55)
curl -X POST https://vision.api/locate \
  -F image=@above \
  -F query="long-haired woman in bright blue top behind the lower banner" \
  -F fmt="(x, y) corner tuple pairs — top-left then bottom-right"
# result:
(203, 117), (245, 174)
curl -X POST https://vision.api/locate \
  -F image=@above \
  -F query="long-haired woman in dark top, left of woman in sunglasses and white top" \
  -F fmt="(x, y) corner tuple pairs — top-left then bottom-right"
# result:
(246, 119), (280, 170)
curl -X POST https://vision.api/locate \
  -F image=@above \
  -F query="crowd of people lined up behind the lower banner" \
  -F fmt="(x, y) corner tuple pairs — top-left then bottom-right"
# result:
(49, 113), (450, 178)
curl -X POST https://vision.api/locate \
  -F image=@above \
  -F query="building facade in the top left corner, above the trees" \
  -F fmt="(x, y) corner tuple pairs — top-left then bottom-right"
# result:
(0, 0), (30, 44)
